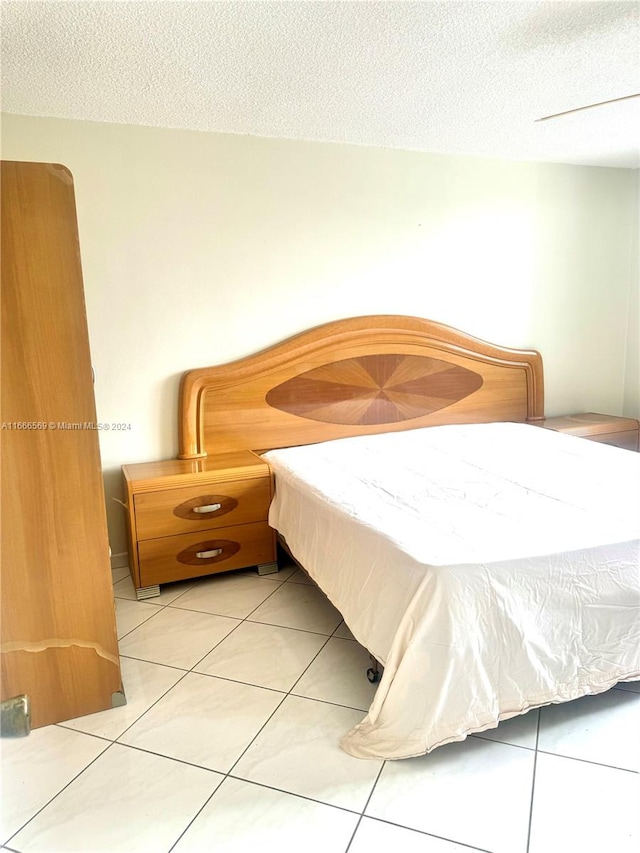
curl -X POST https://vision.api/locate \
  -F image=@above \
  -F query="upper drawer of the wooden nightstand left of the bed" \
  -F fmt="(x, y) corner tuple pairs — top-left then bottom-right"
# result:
(134, 477), (271, 540)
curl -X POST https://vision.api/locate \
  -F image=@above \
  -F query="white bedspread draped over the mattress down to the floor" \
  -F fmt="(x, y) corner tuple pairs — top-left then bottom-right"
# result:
(265, 423), (640, 758)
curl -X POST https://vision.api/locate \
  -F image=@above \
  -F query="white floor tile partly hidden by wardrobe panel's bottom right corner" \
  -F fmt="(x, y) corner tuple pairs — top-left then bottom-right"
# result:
(58, 657), (184, 740)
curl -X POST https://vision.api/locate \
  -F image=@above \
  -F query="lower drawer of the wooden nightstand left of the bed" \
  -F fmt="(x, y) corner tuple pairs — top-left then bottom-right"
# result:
(138, 522), (275, 586)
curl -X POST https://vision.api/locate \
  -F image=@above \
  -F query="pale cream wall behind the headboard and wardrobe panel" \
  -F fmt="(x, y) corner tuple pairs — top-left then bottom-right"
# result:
(2, 111), (638, 552)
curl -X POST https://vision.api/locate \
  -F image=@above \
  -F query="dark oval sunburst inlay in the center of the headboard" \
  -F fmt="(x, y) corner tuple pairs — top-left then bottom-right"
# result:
(266, 353), (482, 425)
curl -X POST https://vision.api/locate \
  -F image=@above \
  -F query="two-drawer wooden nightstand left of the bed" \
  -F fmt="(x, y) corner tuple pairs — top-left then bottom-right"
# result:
(122, 451), (278, 600)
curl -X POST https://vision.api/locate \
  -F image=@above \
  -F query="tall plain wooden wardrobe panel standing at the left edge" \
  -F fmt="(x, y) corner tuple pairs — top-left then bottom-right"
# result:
(1, 162), (121, 727)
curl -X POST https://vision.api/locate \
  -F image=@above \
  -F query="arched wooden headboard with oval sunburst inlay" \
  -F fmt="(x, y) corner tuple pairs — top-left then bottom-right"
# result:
(179, 315), (544, 459)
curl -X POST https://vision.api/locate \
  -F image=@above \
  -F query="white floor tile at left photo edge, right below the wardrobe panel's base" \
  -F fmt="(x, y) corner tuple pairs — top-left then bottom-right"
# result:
(0, 726), (109, 844)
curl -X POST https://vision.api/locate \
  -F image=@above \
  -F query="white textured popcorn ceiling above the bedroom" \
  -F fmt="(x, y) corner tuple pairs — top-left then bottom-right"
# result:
(1, 0), (640, 168)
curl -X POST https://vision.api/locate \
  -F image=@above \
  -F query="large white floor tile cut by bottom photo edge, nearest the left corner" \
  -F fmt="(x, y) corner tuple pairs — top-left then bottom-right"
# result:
(6, 744), (223, 853)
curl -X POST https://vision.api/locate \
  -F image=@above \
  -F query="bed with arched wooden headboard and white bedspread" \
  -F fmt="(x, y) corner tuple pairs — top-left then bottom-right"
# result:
(180, 315), (640, 758)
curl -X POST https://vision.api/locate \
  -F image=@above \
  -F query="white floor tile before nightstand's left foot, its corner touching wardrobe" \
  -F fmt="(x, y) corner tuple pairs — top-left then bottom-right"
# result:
(120, 602), (239, 669)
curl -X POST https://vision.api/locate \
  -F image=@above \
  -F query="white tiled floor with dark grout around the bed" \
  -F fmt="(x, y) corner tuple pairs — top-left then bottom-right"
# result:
(0, 566), (640, 853)
